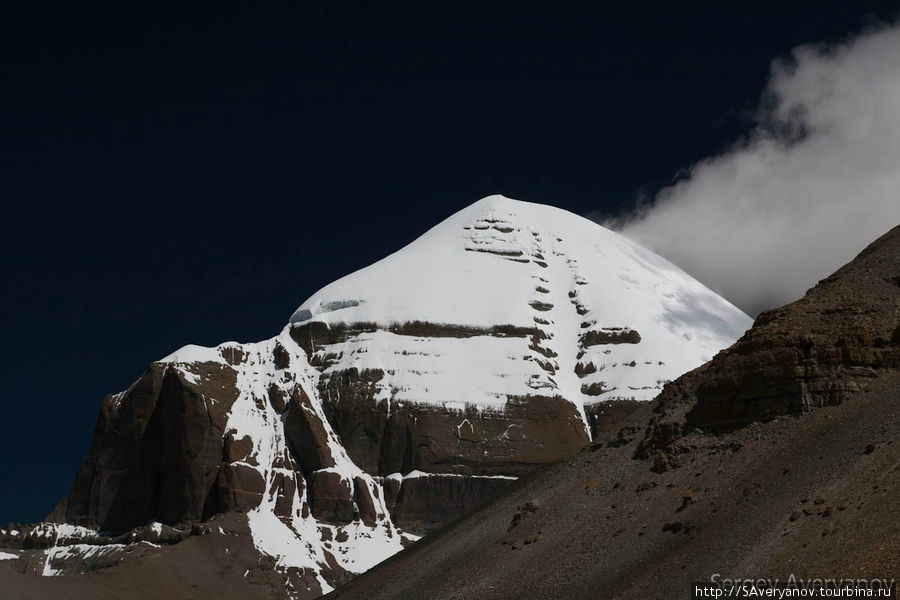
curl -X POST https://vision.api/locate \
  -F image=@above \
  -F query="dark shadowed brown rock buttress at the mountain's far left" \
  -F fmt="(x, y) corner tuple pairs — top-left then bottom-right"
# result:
(66, 363), (237, 530)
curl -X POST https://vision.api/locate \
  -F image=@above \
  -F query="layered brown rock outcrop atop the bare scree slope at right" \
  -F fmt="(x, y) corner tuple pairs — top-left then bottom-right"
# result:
(638, 223), (900, 470)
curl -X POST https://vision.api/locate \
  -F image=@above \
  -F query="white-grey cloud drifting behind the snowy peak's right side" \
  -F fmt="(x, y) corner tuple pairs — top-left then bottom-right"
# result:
(609, 26), (900, 314)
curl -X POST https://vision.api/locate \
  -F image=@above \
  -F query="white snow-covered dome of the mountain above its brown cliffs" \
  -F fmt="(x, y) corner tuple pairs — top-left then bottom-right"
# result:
(291, 195), (751, 407)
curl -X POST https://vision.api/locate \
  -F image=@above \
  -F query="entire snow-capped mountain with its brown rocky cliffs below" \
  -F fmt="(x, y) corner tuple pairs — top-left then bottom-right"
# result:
(0, 197), (749, 597)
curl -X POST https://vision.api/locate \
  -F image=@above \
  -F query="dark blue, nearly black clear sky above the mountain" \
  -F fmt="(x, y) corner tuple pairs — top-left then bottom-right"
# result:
(0, 1), (896, 523)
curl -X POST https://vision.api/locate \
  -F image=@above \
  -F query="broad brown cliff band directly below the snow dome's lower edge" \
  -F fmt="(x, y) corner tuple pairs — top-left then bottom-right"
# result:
(322, 390), (589, 475)
